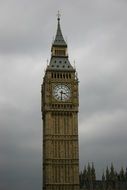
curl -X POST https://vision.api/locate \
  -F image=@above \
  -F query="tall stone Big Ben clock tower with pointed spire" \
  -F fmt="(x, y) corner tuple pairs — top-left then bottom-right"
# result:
(41, 15), (79, 190)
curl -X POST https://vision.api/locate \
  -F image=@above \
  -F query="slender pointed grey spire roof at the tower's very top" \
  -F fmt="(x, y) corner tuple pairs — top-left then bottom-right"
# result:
(52, 12), (67, 47)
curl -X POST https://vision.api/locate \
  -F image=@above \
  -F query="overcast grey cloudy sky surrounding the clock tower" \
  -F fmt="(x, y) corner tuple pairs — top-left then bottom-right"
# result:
(0, 0), (127, 190)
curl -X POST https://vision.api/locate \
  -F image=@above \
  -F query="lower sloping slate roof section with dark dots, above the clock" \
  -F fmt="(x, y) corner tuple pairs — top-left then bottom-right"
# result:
(48, 57), (74, 71)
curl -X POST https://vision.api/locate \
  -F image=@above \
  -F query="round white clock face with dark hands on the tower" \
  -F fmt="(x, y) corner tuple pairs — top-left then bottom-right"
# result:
(53, 84), (71, 101)
